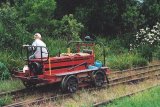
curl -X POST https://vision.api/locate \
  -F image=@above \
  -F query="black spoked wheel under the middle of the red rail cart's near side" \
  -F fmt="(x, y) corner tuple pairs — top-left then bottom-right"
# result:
(61, 75), (78, 93)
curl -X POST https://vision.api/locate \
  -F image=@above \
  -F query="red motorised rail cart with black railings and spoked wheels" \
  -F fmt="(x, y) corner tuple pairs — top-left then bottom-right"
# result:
(14, 37), (109, 92)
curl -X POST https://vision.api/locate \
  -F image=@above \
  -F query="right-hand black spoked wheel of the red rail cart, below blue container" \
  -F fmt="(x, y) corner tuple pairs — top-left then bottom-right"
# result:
(93, 71), (105, 87)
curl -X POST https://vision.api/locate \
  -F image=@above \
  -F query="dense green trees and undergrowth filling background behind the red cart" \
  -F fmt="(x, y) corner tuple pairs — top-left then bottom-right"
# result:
(0, 0), (160, 77)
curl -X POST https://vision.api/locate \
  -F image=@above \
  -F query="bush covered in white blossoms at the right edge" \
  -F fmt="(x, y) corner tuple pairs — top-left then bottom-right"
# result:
(130, 23), (160, 61)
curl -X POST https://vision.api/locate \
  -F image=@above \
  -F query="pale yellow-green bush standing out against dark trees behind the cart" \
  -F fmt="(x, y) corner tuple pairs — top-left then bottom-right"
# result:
(52, 14), (84, 41)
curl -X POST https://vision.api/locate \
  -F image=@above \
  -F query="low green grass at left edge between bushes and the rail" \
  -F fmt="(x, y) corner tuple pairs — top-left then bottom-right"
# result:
(0, 80), (24, 92)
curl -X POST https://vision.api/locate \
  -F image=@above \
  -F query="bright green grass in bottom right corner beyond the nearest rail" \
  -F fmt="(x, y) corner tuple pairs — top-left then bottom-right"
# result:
(104, 86), (160, 107)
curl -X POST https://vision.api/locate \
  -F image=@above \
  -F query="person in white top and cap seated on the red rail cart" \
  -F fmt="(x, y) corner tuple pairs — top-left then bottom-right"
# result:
(29, 33), (48, 59)
